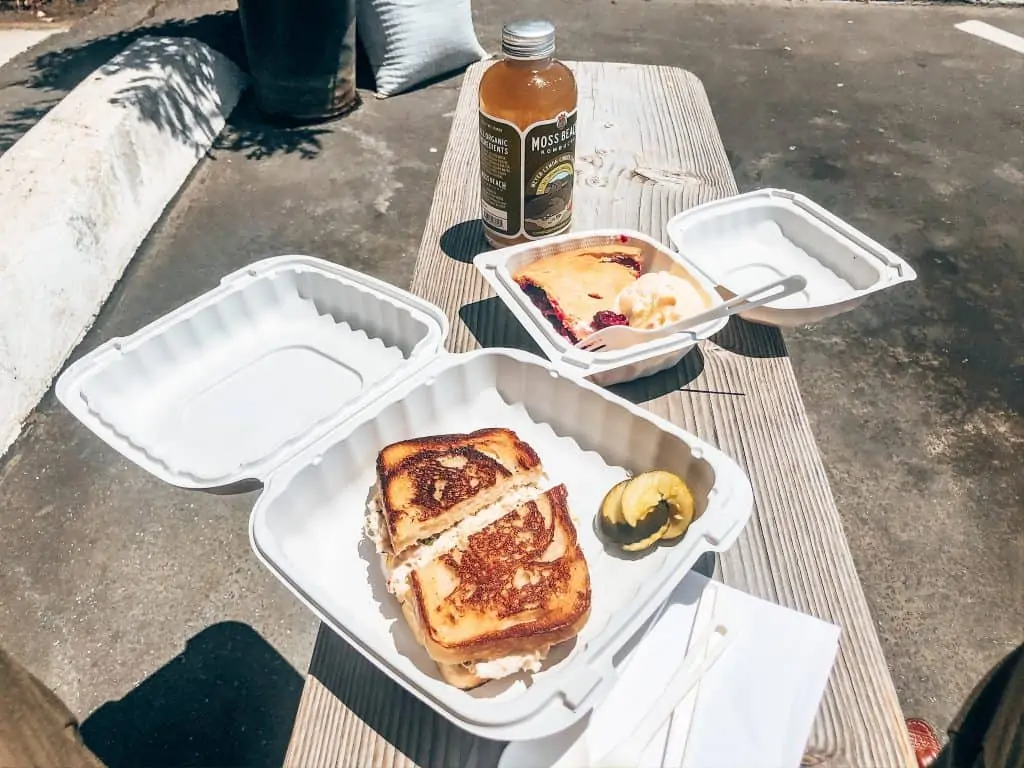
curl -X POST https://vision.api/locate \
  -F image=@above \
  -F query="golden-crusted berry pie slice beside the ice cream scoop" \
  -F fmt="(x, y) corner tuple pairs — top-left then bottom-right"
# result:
(512, 245), (642, 344)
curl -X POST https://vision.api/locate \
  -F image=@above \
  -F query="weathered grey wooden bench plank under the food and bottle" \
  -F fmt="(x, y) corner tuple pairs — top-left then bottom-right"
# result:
(286, 62), (914, 768)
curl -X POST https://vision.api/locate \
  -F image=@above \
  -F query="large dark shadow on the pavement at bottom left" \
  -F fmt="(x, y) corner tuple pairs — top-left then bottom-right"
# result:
(81, 622), (303, 768)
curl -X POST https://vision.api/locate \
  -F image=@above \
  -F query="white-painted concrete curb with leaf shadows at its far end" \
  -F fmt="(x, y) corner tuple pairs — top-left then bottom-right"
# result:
(0, 38), (245, 455)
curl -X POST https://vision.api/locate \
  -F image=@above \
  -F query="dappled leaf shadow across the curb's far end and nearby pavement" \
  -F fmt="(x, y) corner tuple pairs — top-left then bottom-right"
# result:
(0, 11), (329, 160)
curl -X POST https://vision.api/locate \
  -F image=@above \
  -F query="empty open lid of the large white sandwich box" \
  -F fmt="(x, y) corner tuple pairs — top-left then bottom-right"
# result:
(56, 256), (447, 489)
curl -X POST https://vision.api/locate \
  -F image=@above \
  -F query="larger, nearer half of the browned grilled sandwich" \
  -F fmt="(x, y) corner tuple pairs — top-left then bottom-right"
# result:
(402, 485), (591, 687)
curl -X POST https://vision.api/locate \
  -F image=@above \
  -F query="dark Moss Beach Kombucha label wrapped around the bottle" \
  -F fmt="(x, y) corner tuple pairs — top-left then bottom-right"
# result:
(480, 110), (577, 239)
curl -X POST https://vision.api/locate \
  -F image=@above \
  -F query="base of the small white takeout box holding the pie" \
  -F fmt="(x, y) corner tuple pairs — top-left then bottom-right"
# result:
(473, 229), (728, 386)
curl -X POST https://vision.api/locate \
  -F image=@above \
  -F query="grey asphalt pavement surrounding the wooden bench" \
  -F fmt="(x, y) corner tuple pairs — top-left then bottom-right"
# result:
(0, 0), (1024, 762)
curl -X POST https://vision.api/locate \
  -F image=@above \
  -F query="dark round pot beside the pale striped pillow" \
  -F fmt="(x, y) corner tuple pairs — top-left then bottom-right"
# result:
(239, 0), (359, 123)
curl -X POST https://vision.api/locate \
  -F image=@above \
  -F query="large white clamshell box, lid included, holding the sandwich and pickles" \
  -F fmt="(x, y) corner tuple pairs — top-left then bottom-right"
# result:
(56, 256), (753, 740)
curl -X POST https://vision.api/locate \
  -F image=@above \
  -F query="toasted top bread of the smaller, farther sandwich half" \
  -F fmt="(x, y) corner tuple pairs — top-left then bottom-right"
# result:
(377, 429), (542, 554)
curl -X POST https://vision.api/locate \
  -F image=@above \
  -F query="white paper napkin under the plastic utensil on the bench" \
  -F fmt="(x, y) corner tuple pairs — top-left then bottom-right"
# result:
(501, 571), (839, 768)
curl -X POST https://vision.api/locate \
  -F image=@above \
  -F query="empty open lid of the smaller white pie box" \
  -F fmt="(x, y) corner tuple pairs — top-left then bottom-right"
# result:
(667, 189), (916, 327)
